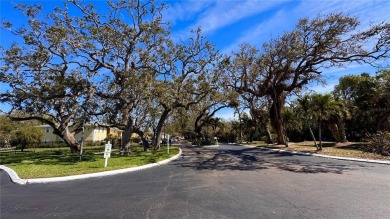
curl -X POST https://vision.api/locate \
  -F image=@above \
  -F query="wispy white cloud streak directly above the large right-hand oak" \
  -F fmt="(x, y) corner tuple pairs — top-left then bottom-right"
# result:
(223, 0), (390, 52)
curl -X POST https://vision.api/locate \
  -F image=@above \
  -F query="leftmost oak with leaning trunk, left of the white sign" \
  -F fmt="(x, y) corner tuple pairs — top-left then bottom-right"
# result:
(0, 5), (94, 152)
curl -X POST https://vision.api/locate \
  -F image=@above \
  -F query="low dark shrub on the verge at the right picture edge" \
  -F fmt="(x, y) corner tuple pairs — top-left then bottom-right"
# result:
(363, 132), (390, 156)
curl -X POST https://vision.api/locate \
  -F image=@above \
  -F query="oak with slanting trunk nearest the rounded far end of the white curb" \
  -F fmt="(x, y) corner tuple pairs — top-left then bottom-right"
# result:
(151, 29), (221, 149)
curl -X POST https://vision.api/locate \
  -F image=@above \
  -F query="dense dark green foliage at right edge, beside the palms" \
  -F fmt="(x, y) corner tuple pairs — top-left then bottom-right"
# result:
(333, 70), (390, 140)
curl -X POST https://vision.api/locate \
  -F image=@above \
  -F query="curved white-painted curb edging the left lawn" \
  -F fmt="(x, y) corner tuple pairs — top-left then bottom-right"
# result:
(0, 148), (182, 185)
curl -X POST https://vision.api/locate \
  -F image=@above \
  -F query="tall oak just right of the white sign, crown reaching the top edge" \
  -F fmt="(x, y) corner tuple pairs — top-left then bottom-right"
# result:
(47, 0), (172, 153)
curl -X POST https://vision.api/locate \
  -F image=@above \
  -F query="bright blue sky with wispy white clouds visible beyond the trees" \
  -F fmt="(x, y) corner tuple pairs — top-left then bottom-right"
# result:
(0, 0), (390, 119)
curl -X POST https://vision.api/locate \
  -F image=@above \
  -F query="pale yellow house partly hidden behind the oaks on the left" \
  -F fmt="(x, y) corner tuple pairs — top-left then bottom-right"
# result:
(37, 124), (122, 142)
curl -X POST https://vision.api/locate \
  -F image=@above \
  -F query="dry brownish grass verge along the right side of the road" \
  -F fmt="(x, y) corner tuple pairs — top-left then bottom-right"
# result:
(247, 141), (390, 161)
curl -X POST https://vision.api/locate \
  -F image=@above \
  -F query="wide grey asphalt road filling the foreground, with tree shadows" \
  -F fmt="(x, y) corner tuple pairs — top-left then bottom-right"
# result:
(0, 145), (390, 219)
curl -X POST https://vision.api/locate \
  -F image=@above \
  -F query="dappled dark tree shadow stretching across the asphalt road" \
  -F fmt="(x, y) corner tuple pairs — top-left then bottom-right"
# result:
(174, 145), (367, 174)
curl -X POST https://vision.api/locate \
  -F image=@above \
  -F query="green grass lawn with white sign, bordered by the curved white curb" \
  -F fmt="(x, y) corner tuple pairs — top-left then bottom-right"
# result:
(0, 145), (179, 179)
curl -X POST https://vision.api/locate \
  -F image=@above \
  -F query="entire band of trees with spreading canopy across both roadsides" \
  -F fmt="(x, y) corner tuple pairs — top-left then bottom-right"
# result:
(0, 0), (390, 153)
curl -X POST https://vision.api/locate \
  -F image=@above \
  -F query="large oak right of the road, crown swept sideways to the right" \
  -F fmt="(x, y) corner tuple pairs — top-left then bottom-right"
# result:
(228, 13), (390, 144)
